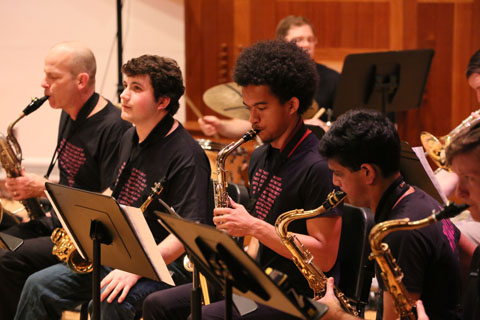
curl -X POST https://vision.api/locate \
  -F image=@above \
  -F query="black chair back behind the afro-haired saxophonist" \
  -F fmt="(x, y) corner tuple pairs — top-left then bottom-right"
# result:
(338, 204), (375, 317)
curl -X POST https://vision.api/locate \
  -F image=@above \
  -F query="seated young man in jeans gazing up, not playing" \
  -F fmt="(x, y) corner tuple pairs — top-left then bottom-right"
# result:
(15, 55), (212, 320)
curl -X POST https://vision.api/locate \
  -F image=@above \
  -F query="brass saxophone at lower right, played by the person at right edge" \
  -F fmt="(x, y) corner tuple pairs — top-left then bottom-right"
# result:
(369, 203), (468, 320)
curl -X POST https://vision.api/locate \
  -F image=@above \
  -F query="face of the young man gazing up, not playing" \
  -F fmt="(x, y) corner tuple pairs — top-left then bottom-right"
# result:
(120, 74), (159, 126)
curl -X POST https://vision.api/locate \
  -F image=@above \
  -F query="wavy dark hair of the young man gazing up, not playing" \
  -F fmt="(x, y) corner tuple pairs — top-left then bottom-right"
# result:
(122, 54), (185, 116)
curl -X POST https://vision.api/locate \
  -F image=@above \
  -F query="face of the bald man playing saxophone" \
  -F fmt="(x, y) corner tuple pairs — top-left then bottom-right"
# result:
(41, 48), (79, 109)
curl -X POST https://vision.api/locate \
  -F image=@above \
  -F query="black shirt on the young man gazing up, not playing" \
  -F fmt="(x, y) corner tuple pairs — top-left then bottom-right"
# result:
(112, 116), (212, 242)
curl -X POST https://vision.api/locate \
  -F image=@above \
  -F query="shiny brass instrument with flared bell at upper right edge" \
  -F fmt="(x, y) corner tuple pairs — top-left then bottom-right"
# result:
(420, 110), (480, 171)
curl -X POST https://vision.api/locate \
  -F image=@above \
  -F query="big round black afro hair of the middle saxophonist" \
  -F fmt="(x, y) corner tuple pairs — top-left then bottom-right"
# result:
(233, 40), (318, 114)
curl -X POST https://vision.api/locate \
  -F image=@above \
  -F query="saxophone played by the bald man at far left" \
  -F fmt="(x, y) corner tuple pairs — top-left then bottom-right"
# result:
(0, 96), (48, 219)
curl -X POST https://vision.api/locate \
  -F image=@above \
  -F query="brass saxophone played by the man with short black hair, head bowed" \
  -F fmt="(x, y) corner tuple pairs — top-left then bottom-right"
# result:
(275, 190), (358, 316)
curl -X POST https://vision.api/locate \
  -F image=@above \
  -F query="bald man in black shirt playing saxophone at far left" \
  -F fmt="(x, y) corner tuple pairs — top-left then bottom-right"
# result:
(0, 42), (130, 320)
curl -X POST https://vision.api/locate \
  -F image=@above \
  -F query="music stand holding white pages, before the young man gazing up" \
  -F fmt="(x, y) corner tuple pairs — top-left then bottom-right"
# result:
(45, 182), (175, 320)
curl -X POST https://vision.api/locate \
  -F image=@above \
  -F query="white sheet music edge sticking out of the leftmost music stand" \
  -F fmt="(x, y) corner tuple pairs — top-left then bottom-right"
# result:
(121, 205), (175, 286)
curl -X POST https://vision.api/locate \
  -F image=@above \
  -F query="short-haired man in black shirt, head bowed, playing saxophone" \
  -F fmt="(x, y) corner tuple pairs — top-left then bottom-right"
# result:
(320, 110), (463, 319)
